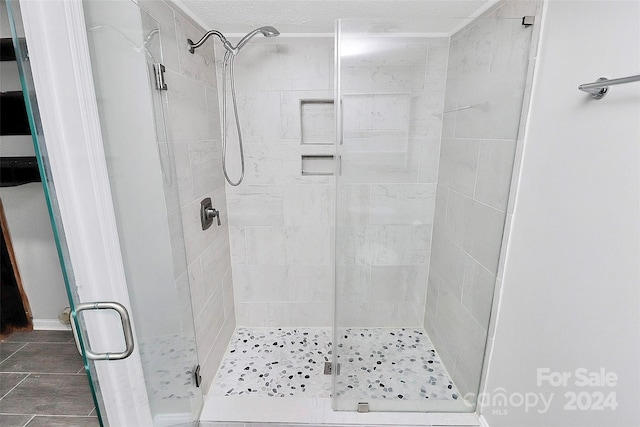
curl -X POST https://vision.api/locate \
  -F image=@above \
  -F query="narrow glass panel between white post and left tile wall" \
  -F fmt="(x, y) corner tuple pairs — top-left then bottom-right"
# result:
(84, 1), (203, 426)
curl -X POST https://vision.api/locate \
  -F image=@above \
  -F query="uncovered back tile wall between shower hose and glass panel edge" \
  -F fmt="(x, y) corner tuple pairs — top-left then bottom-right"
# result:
(216, 37), (335, 327)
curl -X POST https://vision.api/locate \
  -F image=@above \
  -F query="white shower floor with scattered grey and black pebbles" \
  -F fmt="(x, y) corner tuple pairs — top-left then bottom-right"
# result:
(212, 327), (459, 400)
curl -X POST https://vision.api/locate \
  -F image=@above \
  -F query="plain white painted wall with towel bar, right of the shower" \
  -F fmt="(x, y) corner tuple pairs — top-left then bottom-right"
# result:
(481, 1), (640, 427)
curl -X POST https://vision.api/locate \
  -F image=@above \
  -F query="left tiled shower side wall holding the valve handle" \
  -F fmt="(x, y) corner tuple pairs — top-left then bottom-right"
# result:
(138, 0), (235, 390)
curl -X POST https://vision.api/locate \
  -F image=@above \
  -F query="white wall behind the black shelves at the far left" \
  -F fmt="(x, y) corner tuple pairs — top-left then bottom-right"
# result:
(0, 0), (69, 329)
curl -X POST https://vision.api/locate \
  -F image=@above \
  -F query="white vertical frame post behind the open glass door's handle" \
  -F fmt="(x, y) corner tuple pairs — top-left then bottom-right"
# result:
(20, 0), (153, 426)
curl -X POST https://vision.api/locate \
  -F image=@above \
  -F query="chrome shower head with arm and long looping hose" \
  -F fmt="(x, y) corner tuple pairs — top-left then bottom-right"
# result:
(187, 26), (280, 187)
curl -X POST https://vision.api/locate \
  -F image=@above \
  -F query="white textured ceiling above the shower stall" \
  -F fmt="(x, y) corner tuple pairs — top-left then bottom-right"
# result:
(178, 0), (495, 35)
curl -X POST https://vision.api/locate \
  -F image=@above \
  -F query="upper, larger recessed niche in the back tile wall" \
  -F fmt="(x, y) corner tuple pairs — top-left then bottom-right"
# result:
(300, 99), (336, 145)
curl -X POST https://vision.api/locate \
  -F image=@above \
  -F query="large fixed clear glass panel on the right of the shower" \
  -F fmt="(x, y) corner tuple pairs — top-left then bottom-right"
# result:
(333, 2), (538, 412)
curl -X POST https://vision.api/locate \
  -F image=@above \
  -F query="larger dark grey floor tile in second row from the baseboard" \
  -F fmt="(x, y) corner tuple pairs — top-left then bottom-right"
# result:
(0, 343), (83, 374)
